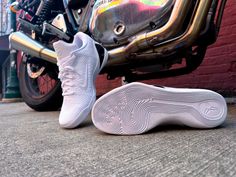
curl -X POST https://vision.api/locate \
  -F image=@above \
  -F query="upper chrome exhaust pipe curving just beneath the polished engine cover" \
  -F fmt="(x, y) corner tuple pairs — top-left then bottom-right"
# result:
(109, 0), (191, 64)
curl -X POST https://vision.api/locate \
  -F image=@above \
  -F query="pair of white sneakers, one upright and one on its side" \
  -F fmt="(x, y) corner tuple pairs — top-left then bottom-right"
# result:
(54, 32), (227, 135)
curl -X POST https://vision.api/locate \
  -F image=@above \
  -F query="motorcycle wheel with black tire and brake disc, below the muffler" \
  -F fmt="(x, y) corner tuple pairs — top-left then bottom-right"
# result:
(19, 56), (63, 111)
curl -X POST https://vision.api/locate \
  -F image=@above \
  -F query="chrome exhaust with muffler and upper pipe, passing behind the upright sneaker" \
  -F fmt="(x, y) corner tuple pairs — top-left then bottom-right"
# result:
(9, 0), (190, 64)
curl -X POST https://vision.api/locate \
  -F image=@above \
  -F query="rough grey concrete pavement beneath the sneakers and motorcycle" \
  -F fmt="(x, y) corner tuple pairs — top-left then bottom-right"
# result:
(0, 103), (236, 177)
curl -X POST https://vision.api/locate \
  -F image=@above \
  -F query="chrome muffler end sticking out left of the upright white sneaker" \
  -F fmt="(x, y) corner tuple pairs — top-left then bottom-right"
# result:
(9, 31), (57, 63)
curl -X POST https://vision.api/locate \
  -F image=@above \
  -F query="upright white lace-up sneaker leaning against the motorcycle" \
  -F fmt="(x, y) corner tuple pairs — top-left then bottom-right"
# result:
(53, 32), (108, 128)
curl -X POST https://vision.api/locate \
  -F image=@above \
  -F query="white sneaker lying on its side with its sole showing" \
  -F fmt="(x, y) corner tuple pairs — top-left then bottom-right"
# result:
(92, 82), (227, 135)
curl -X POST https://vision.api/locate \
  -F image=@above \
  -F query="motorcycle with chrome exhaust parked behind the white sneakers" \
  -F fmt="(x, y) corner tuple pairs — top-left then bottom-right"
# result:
(9, 0), (227, 111)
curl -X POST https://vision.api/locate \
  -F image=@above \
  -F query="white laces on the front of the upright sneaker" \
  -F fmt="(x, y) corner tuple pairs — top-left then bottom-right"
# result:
(58, 66), (80, 96)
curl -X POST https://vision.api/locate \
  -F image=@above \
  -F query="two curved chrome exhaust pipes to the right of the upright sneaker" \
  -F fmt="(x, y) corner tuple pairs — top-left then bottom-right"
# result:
(106, 0), (212, 66)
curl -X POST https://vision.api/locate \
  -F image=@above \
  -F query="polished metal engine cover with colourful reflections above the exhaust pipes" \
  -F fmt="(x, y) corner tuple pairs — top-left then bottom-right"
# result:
(89, 0), (175, 47)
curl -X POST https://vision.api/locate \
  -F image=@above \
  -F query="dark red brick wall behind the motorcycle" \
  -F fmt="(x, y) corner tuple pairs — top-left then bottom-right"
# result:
(97, 0), (236, 96)
